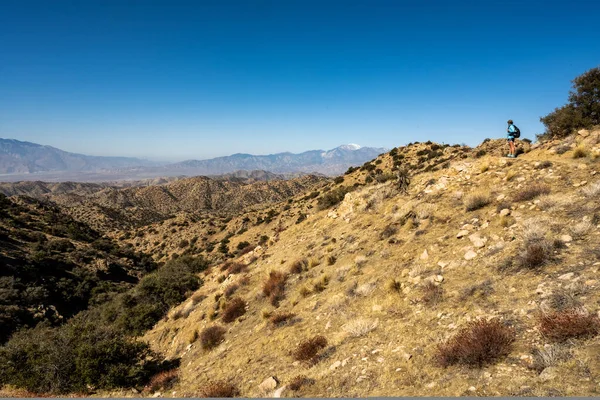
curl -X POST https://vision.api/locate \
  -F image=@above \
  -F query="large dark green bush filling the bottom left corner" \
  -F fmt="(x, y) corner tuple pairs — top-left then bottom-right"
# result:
(0, 317), (152, 394)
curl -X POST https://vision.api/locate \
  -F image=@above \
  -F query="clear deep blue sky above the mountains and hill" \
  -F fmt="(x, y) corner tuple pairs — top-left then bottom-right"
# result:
(0, 0), (600, 160)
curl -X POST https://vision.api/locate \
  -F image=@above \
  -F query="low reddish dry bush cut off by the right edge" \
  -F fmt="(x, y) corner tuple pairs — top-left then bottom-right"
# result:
(539, 309), (600, 342)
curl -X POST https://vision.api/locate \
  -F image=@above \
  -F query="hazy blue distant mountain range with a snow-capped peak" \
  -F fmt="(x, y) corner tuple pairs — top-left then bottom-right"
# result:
(0, 139), (387, 181)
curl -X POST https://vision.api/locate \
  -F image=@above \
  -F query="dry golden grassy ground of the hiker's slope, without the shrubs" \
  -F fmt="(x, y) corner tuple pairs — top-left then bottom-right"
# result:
(129, 131), (600, 397)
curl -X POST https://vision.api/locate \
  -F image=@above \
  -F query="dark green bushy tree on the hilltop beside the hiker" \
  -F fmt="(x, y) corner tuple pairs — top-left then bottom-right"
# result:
(538, 67), (600, 139)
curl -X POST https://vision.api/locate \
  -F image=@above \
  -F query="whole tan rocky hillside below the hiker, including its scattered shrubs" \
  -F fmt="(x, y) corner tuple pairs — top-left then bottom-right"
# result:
(129, 131), (600, 397)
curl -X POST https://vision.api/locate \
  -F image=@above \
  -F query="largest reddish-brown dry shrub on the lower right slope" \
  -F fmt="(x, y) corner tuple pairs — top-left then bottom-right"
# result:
(437, 319), (515, 368)
